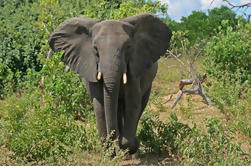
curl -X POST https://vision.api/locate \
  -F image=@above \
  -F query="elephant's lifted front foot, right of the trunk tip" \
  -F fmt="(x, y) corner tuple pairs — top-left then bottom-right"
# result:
(119, 137), (139, 154)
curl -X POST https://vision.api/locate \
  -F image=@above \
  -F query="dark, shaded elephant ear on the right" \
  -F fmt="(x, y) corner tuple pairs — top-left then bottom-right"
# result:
(121, 14), (172, 77)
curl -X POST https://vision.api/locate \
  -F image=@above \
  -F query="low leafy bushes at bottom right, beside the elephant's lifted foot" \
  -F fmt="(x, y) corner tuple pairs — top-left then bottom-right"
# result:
(138, 112), (251, 165)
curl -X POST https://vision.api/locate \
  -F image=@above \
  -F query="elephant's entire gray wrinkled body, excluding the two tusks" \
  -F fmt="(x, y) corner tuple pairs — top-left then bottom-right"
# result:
(49, 14), (172, 153)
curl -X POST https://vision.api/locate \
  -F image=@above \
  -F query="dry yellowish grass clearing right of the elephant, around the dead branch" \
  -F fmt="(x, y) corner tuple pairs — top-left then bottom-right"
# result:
(148, 58), (251, 154)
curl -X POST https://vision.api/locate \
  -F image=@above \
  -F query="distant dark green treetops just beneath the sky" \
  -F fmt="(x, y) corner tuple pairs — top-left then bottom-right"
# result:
(169, 6), (237, 45)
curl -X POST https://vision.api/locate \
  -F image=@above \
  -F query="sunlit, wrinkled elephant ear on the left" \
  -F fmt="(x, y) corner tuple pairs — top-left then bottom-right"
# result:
(49, 17), (99, 82)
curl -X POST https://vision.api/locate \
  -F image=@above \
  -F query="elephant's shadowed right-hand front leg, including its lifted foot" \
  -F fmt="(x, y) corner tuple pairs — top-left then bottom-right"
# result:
(119, 80), (141, 154)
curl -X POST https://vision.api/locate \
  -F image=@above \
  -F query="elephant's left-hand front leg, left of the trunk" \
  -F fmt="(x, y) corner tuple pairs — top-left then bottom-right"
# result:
(85, 81), (107, 144)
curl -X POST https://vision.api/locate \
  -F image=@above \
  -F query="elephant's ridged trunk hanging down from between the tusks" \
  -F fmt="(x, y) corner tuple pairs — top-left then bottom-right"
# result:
(103, 73), (122, 139)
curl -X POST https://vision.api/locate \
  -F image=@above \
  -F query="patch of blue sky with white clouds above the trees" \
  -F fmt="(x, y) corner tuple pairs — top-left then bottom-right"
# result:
(159, 0), (251, 21)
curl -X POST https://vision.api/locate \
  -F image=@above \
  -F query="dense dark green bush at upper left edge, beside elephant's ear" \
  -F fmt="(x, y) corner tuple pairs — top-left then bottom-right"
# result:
(0, 1), (42, 96)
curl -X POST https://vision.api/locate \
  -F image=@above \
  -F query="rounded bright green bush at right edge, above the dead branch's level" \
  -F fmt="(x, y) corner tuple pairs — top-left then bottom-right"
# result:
(204, 20), (251, 82)
